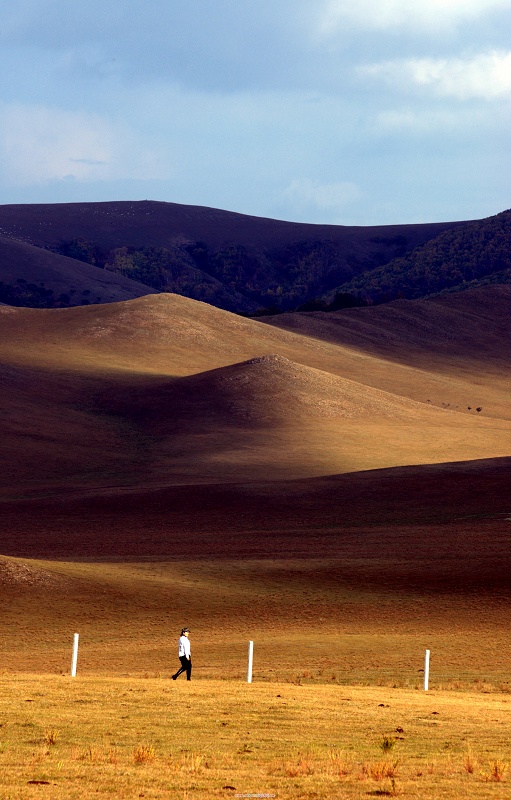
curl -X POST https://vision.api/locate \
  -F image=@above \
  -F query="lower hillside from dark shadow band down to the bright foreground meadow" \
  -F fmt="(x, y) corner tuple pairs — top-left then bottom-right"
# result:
(0, 459), (511, 691)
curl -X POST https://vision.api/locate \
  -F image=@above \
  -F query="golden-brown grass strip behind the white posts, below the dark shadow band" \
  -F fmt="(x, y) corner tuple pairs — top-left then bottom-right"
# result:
(0, 552), (511, 696)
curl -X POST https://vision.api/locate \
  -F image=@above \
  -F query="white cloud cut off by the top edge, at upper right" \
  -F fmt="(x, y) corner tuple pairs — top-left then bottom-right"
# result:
(319, 0), (509, 36)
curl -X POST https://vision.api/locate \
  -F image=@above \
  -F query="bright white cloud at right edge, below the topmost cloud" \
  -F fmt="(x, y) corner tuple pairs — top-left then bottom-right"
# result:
(359, 52), (511, 100)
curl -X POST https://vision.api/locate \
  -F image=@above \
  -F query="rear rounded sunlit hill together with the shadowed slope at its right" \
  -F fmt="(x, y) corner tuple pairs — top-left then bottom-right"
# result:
(0, 287), (511, 418)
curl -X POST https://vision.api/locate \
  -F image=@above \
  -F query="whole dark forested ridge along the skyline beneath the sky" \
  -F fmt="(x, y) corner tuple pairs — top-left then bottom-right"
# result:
(0, 201), (511, 314)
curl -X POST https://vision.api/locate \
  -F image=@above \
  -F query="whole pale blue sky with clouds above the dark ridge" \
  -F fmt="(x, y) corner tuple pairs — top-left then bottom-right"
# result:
(0, 0), (511, 225)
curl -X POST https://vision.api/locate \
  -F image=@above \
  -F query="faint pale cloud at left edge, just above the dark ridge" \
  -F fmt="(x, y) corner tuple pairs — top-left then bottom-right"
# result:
(0, 104), (169, 186)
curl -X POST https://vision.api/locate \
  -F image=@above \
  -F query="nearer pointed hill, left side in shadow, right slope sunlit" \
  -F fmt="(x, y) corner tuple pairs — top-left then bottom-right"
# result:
(98, 355), (511, 483)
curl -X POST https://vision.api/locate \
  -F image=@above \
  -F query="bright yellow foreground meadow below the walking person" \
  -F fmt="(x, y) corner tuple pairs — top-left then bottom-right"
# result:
(0, 675), (511, 800)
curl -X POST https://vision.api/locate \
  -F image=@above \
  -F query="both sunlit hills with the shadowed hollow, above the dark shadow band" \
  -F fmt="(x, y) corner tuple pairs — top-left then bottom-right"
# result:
(0, 290), (511, 496)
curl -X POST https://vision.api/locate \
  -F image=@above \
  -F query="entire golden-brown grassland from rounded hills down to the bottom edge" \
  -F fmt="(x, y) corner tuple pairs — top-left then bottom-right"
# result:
(0, 286), (511, 800)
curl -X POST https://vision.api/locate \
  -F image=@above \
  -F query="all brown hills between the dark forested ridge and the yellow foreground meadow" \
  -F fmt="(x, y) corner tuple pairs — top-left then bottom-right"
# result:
(0, 286), (511, 685)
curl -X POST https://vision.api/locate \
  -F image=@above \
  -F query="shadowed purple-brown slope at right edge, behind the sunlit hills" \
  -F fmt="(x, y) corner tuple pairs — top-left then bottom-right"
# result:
(264, 285), (511, 416)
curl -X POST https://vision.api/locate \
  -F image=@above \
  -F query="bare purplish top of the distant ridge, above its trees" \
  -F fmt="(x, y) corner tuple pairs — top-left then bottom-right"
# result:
(0, 200), (461, 252)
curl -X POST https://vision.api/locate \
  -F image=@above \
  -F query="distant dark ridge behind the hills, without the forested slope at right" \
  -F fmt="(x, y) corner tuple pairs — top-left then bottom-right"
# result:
(0, 201), (463, 314)
